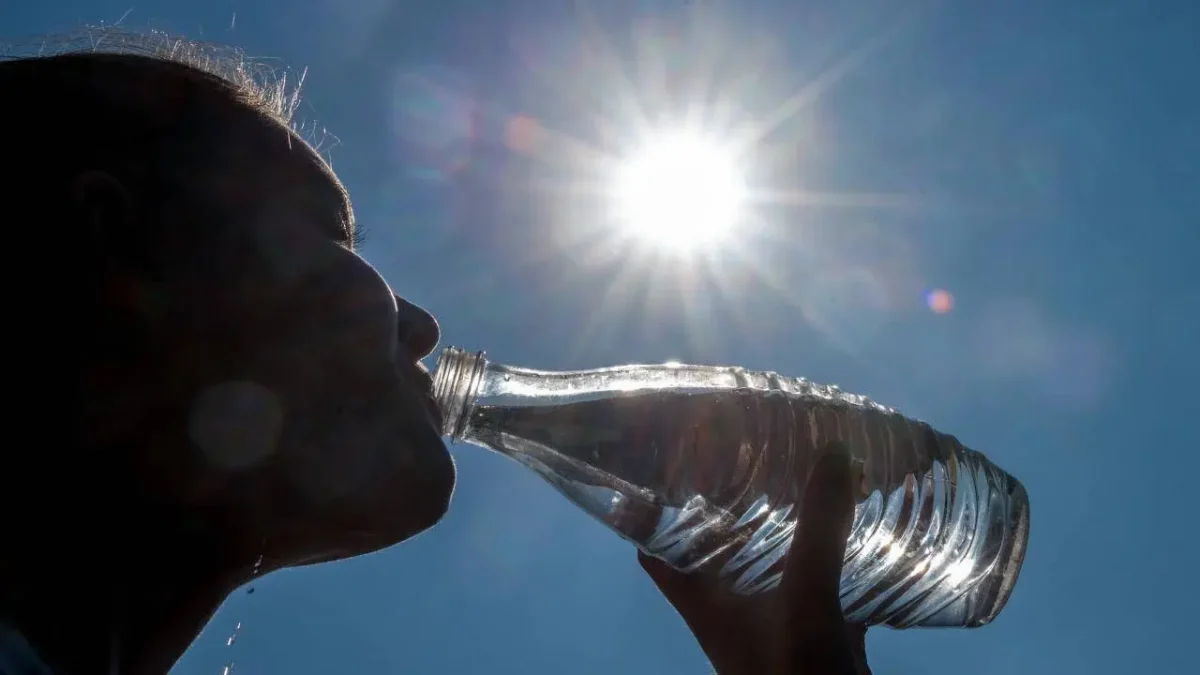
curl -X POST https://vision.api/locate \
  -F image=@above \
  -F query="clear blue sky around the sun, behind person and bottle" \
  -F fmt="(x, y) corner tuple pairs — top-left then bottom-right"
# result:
(0, 0), (1200, 675)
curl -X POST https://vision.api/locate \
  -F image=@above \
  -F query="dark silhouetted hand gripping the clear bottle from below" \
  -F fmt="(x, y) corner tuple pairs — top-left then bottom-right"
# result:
(638, 444), (870, 675)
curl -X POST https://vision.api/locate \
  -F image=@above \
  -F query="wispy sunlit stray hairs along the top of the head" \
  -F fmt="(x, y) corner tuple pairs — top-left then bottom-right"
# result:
(0, 26), (306, 129)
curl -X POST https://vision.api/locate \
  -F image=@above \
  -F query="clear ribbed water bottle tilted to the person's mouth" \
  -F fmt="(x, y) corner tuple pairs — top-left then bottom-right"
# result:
(433, 347), (1030, 628)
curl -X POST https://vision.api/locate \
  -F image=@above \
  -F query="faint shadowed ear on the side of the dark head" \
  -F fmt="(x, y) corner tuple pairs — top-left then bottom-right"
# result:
(71, 171), (160, 281)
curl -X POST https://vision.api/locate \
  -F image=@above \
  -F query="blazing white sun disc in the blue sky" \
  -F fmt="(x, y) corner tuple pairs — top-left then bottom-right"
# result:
(616, 133), (745, 251)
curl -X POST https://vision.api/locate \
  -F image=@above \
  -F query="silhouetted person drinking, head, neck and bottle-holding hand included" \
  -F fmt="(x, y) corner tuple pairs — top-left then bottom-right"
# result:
(0, 35), (868, 675)
